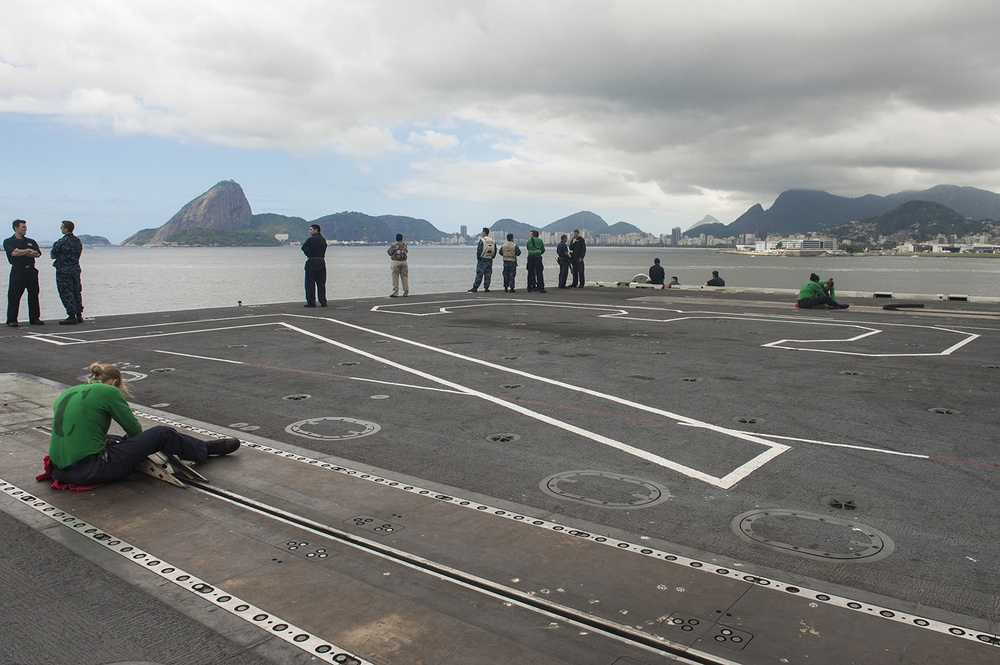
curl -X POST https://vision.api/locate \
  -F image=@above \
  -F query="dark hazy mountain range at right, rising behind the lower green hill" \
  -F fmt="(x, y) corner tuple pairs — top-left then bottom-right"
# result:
(700, 185), (1000, 238)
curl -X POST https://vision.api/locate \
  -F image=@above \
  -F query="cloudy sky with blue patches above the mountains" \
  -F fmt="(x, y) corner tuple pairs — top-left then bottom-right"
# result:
(0, 0), (1000, 242)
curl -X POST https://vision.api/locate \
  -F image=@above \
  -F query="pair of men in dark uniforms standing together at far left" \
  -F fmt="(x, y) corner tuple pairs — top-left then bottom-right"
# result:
(3, 219), (83, 328)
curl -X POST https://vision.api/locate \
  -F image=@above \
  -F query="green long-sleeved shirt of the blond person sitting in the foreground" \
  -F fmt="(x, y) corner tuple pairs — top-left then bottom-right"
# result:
(49, 383), (142, 467)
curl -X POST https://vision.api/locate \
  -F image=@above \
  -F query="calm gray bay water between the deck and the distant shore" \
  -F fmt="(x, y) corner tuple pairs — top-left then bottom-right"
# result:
(21, 246), (1000, 321)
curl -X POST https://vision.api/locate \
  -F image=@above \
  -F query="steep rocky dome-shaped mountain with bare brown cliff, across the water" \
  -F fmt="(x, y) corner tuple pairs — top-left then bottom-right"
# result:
(122, 180), (254, 246)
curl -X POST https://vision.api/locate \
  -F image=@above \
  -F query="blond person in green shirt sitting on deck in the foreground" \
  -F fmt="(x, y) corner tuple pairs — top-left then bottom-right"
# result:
(49, 363), (240, 485)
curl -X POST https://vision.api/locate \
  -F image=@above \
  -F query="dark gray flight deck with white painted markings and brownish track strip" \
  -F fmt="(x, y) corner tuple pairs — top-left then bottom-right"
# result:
(0, 287), (1000, 665)
